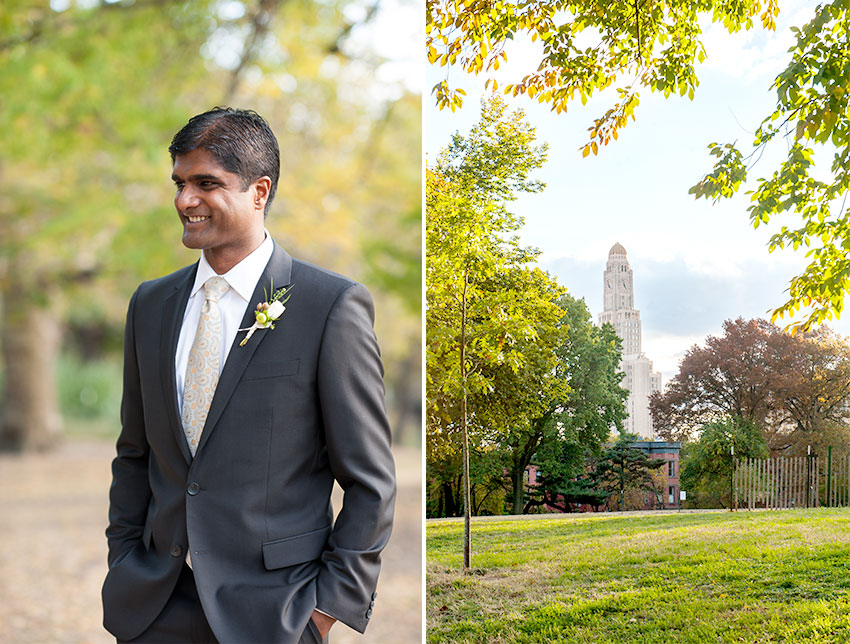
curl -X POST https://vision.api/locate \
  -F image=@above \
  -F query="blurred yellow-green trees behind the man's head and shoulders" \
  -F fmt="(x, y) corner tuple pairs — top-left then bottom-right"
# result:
(0, 0), (421, 450)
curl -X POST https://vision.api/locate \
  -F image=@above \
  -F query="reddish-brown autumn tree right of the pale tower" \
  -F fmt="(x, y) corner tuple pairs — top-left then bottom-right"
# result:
(650, 318), (850, 453)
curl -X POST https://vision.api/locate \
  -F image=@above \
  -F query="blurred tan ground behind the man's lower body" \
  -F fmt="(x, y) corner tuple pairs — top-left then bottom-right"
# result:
(0, 440), (422, 644)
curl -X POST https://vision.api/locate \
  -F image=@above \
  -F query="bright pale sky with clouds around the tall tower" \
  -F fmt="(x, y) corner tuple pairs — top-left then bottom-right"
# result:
(425, 0), (850, 382)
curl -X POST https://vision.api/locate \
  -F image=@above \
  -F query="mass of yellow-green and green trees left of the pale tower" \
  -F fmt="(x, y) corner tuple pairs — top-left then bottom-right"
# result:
(426, 96), (626, 516)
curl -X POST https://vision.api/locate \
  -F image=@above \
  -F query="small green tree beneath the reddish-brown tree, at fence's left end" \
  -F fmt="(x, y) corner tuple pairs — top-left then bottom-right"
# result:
(680, 418), (770, 508)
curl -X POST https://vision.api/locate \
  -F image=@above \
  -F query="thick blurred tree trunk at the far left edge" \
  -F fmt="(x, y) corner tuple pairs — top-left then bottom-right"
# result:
(0, 271), (62, 451)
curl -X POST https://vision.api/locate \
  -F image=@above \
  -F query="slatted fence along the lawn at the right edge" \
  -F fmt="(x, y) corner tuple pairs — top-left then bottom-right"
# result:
(732, 450), (850, 510)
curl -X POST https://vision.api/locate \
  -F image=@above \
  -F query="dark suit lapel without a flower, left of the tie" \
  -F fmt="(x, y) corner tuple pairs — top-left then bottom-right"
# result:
(159, 264), (198, 463)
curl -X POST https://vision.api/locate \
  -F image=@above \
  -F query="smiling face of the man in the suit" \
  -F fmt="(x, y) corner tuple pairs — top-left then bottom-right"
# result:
(171, 148), (270, 274)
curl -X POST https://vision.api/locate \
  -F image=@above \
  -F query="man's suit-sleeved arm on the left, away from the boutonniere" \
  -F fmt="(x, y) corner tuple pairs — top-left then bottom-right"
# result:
(106, 290), (151, 566)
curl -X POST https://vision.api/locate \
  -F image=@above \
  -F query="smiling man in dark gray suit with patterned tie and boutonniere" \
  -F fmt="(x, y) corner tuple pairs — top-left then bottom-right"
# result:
(103, 108), (395, 644)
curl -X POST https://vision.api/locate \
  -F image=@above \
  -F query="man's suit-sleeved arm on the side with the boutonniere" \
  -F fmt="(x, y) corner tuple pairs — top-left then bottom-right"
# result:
(317, 284), (396, 632)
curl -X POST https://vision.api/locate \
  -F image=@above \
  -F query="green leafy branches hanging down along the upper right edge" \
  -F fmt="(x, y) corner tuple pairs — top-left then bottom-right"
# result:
(691, 0), (850, 329)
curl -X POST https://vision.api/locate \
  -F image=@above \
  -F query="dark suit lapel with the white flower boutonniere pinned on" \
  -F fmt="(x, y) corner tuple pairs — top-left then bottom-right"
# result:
(195, 242), (292, 457)
